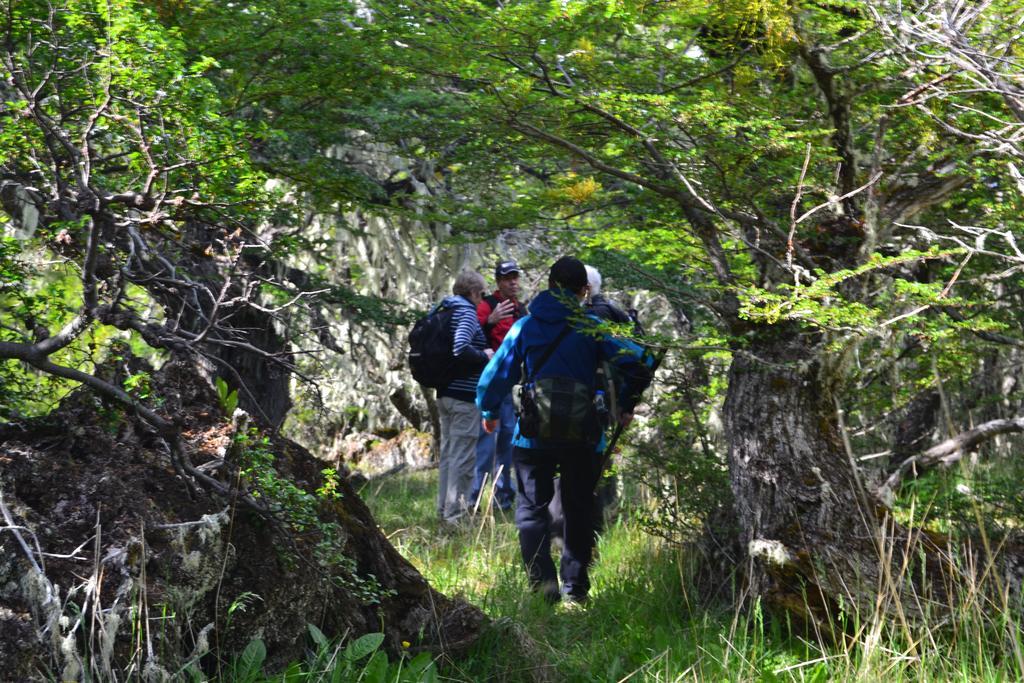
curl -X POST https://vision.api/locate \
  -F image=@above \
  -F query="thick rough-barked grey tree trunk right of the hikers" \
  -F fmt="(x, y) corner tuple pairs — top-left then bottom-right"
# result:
(724, 330), (938, 635)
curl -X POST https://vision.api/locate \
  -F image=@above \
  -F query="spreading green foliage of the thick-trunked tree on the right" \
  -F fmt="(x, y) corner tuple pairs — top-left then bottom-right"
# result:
(350, 0), (1012, 374)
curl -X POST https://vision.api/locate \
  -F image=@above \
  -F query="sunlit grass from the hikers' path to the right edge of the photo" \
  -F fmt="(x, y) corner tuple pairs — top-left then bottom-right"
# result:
(361, 472), (1024, 683)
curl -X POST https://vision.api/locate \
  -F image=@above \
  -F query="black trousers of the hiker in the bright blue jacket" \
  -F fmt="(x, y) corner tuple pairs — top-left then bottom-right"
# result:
(512, 444), (598, 600)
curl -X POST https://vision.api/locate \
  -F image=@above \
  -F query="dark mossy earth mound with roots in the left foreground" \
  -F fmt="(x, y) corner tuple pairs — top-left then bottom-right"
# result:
(0, 364), (484, 680)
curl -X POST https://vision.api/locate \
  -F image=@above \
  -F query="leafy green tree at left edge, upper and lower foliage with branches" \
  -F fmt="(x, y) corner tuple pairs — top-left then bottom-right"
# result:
(0, 0), (269, 419)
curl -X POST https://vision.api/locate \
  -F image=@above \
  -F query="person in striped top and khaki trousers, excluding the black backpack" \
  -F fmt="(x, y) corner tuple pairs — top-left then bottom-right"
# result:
(437, 270), (494, 524)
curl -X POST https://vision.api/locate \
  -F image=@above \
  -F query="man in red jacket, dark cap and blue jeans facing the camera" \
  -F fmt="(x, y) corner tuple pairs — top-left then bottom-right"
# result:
(470, 260), (526, 510)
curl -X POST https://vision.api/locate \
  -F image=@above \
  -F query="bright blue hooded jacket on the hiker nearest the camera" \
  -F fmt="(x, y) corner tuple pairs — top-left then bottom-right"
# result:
(476, 290), (650, 449)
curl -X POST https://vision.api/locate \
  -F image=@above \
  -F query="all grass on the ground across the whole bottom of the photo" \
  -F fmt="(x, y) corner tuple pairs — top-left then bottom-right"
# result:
(24, 472), (1024, 683)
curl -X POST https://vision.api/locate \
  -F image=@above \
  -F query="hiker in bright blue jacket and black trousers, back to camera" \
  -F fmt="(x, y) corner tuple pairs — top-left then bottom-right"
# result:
(476, 256), (650, 602)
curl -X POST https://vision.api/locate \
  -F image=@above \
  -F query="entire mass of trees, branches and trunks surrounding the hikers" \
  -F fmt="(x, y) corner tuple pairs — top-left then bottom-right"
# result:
(0, 0), (1024, 671)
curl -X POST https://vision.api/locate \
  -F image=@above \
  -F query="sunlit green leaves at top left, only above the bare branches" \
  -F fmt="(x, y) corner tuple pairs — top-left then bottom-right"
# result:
(0, 0), (272, 222)
